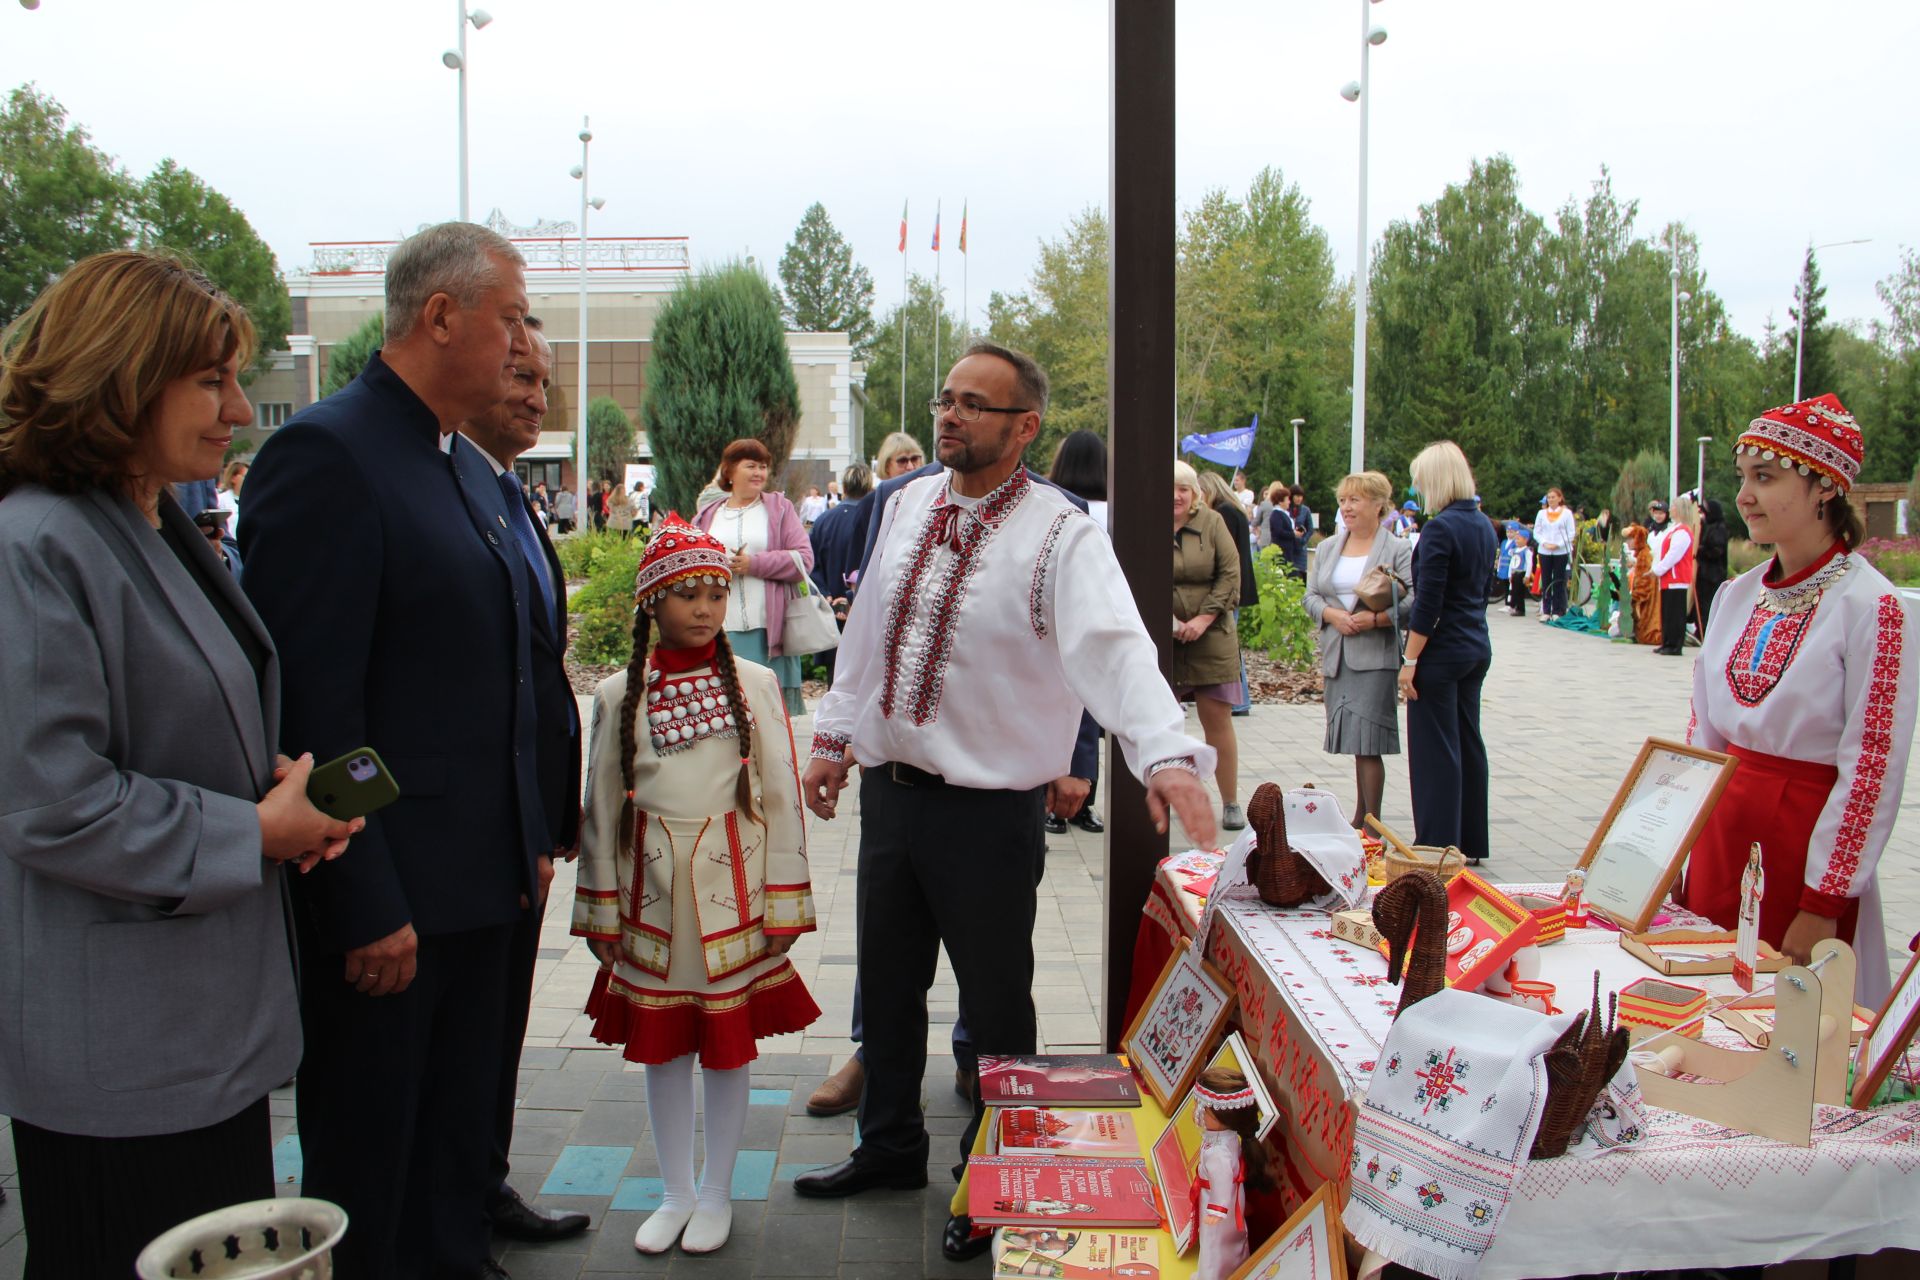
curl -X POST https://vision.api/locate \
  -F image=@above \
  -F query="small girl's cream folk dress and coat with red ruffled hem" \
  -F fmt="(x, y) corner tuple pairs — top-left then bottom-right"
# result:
(572, 660), (820, 1071)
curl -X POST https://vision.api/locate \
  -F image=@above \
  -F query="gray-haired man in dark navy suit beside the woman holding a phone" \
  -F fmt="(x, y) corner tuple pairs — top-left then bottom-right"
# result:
(242, 223), (553, 1280)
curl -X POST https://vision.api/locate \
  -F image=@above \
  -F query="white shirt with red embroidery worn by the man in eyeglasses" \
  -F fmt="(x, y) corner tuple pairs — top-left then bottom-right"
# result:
(812, 468), (1213, 791)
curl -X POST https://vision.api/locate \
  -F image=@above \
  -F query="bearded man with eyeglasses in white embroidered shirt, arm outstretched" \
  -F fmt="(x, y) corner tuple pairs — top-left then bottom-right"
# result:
(795, 344), (1213, 1257)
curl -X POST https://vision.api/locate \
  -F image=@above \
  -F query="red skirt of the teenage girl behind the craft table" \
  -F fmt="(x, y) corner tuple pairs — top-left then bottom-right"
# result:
(1674, 743), (1860, 946)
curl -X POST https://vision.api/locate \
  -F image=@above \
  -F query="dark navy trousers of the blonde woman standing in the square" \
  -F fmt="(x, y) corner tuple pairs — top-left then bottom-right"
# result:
(1407, 658), (1492, 858)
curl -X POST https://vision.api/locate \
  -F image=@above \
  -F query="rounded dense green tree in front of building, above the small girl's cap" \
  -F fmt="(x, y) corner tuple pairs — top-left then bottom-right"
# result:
(641, 261), (801, 512)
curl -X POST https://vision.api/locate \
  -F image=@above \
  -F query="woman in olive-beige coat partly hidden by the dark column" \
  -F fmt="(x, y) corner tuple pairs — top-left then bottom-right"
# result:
(1167, 462), (1246, 831)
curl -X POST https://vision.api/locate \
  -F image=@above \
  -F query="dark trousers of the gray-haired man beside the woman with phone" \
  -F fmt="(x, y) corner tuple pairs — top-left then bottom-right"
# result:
(300, 925), (515, 1280)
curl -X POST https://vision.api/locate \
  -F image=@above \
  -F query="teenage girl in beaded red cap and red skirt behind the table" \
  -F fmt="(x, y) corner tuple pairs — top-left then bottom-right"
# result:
(1680, 395), (1920, 1007)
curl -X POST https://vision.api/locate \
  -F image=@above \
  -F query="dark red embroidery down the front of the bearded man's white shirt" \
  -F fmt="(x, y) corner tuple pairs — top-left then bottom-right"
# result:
(879, 466), (1031, 725)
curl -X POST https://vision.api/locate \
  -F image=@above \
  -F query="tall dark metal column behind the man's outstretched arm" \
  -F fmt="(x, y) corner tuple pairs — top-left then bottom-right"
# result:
(1100, 0), (1173, 1048)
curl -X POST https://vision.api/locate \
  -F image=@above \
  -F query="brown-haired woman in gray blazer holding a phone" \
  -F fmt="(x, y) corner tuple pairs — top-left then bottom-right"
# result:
(0, 253), (359, 1280)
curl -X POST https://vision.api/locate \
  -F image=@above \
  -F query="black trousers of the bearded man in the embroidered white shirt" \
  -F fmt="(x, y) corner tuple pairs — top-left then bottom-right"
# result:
(856, 766), (1046, 1165)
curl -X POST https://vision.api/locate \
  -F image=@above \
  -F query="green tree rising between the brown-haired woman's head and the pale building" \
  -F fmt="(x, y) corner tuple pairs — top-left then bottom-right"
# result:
(134, 159), (294, 372)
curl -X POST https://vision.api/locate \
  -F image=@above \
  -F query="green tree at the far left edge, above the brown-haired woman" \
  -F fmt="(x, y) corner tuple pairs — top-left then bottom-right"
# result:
(0, 84), (134, 324)
